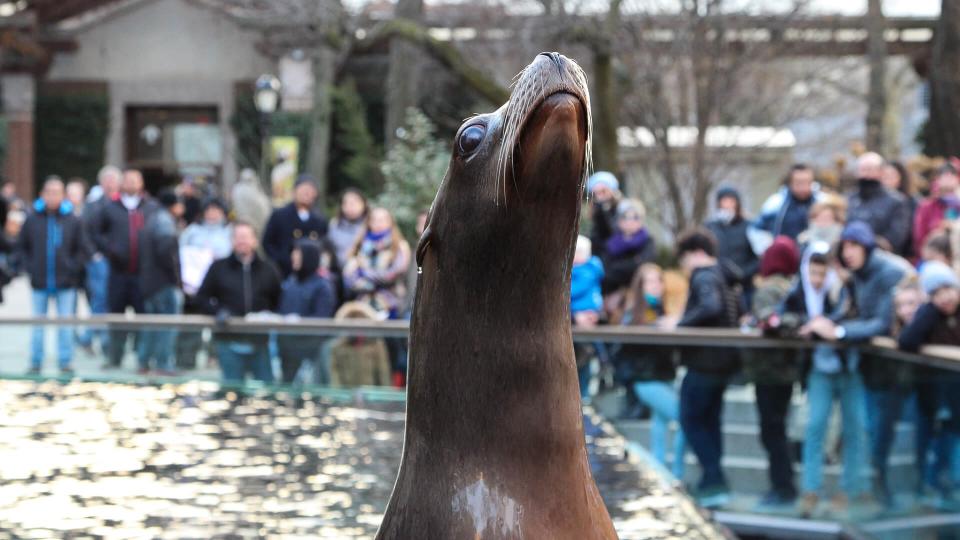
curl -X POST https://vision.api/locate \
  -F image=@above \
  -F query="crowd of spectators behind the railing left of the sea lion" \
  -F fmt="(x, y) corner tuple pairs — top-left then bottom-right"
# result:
(10, 166), (416, 386)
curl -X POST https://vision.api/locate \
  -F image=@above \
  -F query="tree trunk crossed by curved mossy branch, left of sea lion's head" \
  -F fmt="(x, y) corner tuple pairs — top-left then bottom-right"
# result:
(383, 0), (423, 148)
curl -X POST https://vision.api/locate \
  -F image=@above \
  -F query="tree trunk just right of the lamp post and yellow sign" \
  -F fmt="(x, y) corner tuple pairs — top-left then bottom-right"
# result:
(307, 46), (337, 205)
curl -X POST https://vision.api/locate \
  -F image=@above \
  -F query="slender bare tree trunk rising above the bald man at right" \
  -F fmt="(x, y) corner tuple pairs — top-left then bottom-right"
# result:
(866, 0), (887, 154)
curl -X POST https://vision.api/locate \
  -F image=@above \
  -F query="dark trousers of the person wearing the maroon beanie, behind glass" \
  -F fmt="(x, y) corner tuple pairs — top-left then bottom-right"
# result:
(754, 384), (797, 498)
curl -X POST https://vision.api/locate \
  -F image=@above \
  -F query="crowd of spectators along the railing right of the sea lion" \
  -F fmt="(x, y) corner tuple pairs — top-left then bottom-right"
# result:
(571, 153), (960, 516)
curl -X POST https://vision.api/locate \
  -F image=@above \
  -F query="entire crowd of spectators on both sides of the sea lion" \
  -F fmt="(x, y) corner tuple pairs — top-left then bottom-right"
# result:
(11, 147), (960, 515)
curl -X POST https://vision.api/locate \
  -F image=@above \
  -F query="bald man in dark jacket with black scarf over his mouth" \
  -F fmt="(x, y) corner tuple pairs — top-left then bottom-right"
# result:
(847, 152), (913, 256)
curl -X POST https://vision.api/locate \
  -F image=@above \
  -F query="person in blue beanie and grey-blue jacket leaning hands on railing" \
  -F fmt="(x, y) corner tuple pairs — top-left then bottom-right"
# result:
(800, 217), (909, 506)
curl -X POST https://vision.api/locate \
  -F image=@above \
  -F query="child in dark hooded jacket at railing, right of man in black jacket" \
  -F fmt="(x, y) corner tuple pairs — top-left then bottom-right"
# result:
(277, 240), (336, 384)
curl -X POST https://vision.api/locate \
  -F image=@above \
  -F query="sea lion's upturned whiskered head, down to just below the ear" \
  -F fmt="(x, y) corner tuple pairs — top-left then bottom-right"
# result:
(417, 53), (592, 286)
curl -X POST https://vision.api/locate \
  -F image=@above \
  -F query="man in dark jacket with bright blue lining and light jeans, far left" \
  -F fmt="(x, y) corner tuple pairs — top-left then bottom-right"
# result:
(18, 176), (84, 375)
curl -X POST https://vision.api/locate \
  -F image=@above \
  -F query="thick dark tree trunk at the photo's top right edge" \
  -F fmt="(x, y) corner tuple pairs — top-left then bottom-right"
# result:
(927, 0), (960, 156)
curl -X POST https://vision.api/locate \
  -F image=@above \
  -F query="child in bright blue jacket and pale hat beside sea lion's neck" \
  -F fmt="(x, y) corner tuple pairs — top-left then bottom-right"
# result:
(570, 235), (603, 401)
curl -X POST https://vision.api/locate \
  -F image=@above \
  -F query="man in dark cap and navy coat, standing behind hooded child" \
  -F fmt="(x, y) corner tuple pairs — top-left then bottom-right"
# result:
(263, 175), (327, 278)
